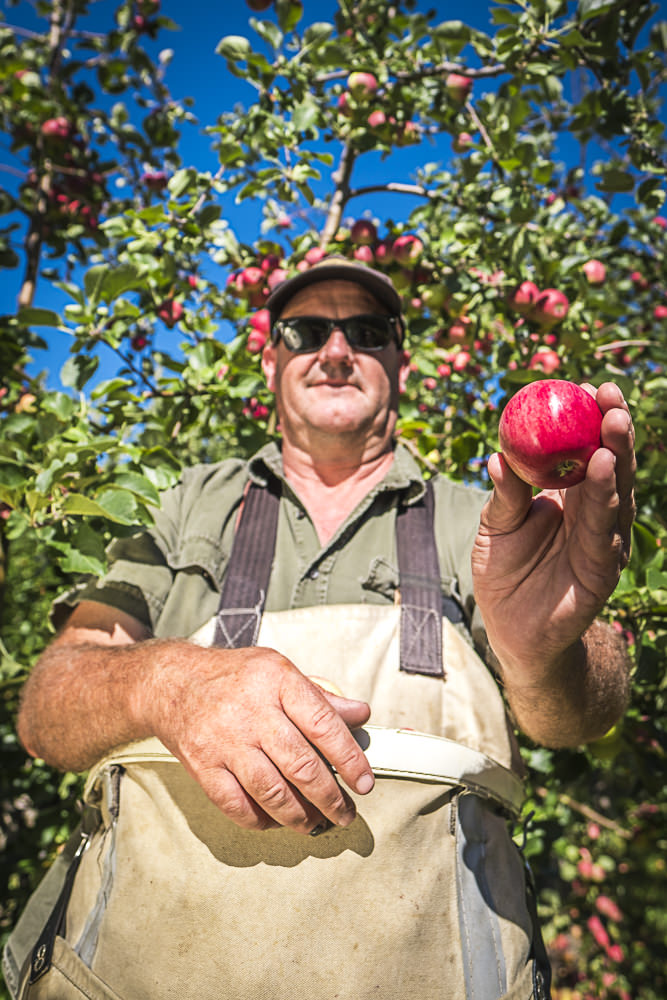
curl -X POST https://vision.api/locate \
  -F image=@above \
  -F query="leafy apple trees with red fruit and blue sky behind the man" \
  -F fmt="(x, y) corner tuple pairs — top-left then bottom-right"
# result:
(0, 0), (667, 1000)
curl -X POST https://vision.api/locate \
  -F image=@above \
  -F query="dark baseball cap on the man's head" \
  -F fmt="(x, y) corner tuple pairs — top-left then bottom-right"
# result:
(266, 255), (405, 340)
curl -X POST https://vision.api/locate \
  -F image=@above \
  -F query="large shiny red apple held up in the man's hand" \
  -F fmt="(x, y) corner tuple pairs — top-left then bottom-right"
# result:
(498, 379), (602, 490)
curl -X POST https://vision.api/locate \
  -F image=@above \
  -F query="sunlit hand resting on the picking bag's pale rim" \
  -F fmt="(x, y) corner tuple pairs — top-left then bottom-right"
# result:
(146, 647), (373, 833)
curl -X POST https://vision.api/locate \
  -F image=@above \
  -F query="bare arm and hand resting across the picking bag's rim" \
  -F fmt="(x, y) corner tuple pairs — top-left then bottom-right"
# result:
(18, 601), (373, 833)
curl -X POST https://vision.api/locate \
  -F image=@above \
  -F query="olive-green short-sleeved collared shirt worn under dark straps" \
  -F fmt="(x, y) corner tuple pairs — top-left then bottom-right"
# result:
(55, 444), (486, 645)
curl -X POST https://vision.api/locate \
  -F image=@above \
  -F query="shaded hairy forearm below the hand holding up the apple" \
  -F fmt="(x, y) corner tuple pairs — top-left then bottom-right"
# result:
(499, 620), (630, 747)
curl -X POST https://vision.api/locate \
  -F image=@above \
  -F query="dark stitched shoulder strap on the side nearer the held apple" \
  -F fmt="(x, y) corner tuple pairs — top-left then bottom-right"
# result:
(396, 480), (444, 677)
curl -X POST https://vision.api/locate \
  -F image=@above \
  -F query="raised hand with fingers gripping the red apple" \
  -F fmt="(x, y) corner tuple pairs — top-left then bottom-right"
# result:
(472, 382), (636, 669)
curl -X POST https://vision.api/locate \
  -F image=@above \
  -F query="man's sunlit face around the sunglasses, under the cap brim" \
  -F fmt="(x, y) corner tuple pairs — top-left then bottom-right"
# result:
(262, 281), (409, 450)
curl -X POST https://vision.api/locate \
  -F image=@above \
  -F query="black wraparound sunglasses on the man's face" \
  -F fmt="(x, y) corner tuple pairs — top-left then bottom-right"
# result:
(271, 315), (403, 354)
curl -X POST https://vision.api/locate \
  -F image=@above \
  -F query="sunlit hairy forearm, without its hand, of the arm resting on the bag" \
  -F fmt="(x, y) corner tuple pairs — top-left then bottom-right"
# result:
(17, 639), (197, 771)
